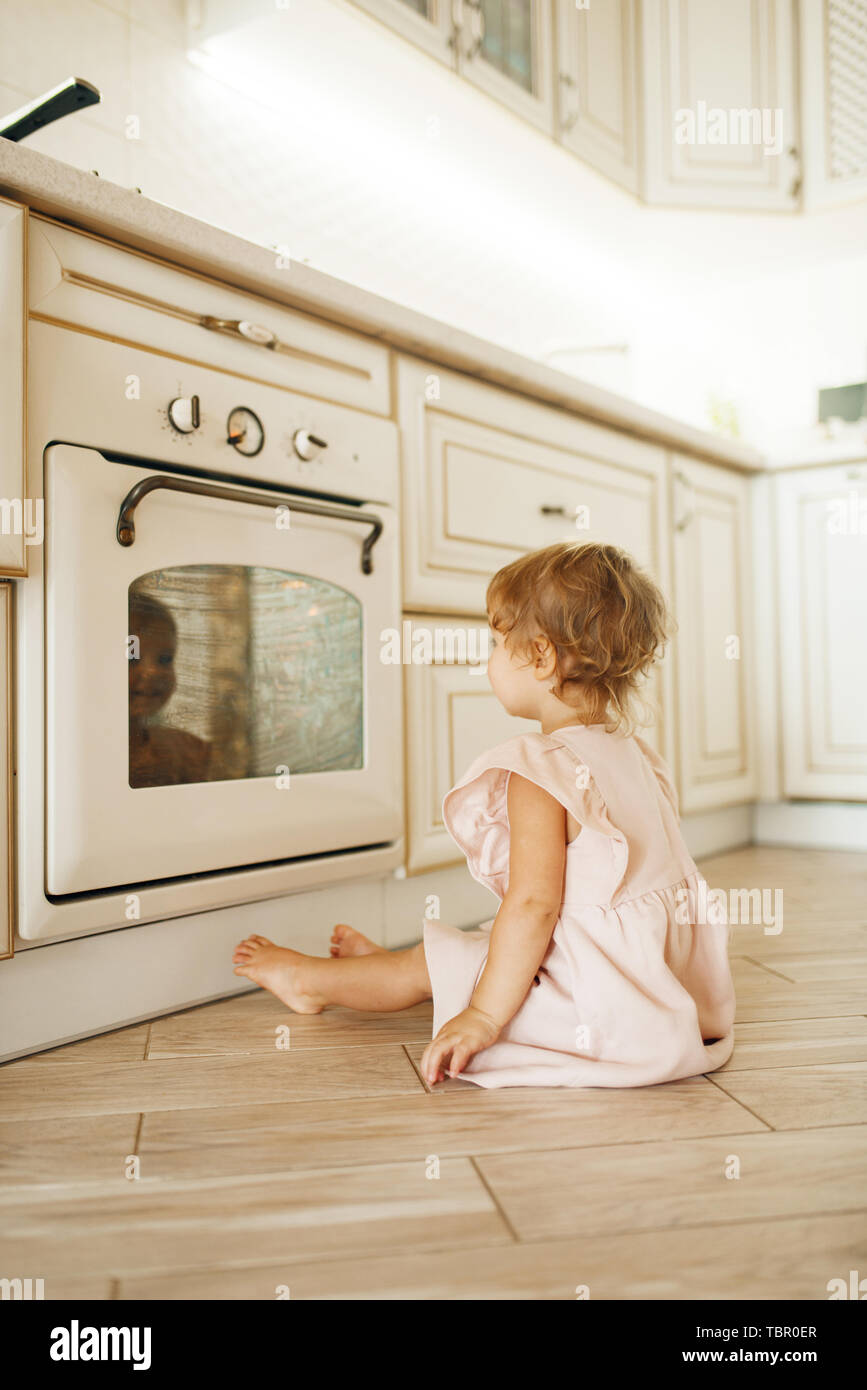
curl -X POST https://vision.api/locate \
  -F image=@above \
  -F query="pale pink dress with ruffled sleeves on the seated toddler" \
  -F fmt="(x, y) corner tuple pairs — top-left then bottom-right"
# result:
(424, 724), (735, 1087)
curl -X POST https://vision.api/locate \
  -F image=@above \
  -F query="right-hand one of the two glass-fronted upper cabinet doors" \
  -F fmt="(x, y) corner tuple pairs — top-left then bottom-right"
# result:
(459, 0), (553, 131)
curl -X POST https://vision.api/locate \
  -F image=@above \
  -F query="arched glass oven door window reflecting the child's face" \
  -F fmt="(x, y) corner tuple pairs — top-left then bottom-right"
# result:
(128, 564), (364, 787)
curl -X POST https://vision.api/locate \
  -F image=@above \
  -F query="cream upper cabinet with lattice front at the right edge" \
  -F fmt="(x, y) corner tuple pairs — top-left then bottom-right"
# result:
(799, 0), (867, 209)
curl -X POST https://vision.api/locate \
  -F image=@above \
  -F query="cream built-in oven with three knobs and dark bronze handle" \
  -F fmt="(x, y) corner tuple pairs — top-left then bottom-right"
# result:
(18, 322), (403, 941)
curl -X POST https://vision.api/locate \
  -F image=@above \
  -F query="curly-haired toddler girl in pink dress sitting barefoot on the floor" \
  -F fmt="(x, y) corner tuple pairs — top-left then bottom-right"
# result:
(233, 543), (735, 1087)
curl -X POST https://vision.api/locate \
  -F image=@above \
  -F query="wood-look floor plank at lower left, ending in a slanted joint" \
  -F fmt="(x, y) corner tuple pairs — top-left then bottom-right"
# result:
(0, 1158), (511, 1279)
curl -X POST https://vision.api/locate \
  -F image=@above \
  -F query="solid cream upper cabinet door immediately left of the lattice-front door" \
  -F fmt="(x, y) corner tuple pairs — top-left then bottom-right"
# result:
(642, 0), (799, 210)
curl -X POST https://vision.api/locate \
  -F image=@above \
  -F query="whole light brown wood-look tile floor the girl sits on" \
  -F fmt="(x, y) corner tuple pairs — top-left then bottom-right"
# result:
(0, 849), (867, 1300)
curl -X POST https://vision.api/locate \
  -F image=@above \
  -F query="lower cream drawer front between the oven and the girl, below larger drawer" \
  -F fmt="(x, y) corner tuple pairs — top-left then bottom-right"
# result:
(404, 613), (538, 873)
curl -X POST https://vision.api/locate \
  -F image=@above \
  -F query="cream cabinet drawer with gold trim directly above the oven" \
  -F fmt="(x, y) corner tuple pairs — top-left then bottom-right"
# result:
(29, 217), (390, 414)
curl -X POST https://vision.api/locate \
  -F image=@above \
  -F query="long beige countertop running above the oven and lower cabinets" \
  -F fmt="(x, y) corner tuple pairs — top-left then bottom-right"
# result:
(0, 138), (766, 471)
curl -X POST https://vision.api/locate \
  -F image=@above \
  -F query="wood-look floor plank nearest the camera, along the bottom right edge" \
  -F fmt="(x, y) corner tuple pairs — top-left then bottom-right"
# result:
(118, 1212), (867, 1322)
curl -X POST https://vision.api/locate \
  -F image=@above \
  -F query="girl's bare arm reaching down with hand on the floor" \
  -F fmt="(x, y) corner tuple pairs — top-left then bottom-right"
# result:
(421, 773), (565, 1084)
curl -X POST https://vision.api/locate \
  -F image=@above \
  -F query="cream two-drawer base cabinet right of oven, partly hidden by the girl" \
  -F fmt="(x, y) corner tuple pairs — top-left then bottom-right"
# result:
(397, 357), (672, 856)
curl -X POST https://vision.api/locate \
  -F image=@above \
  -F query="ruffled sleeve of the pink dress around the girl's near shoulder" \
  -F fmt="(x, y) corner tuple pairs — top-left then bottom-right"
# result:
(443, 734), (628, 899)
